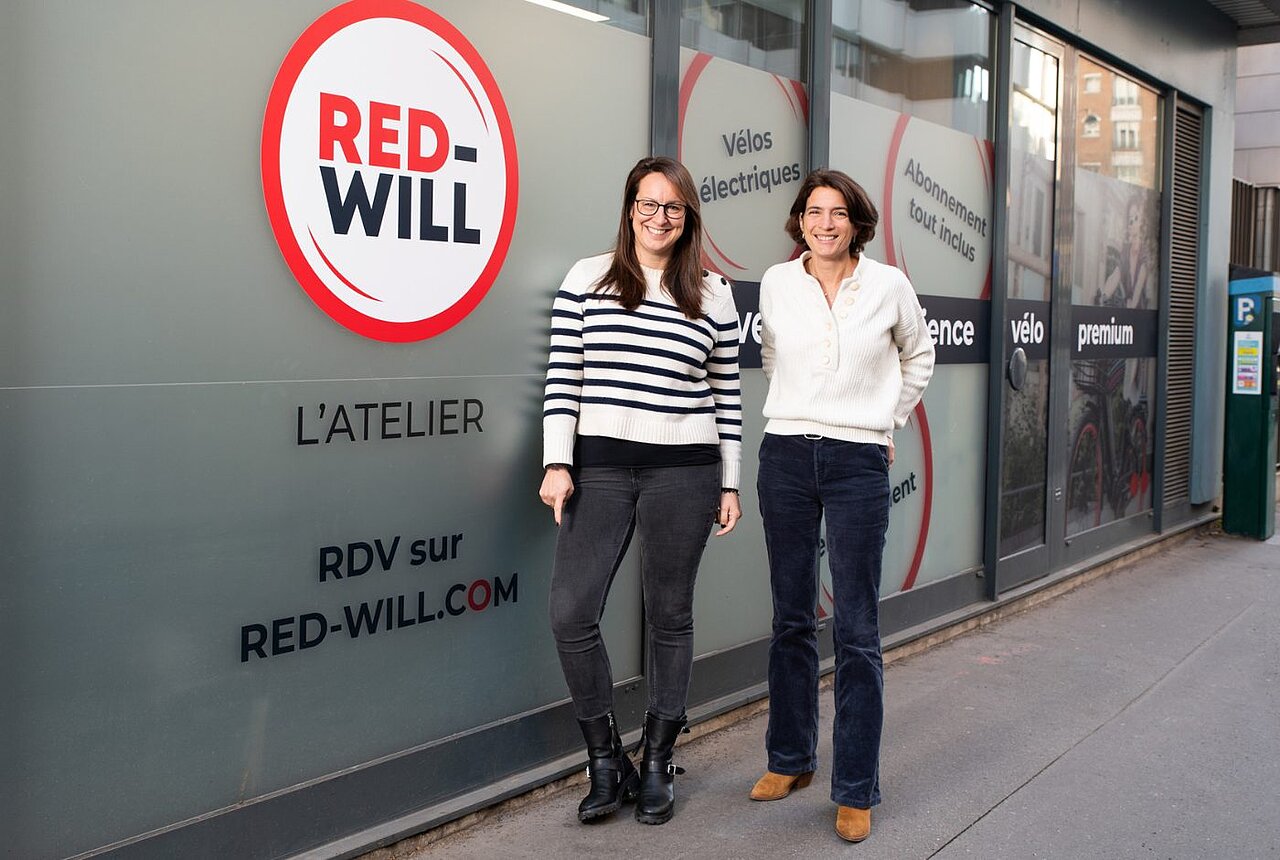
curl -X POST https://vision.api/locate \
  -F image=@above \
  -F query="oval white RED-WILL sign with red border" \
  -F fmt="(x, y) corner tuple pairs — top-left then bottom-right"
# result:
(262, 0), (518, 342)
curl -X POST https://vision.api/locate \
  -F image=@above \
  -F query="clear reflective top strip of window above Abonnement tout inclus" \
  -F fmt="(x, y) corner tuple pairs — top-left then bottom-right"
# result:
(831, 0), (993, 137)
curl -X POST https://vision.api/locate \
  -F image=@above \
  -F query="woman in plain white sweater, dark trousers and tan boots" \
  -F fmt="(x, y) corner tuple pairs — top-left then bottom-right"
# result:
(751, 170), (933, 842)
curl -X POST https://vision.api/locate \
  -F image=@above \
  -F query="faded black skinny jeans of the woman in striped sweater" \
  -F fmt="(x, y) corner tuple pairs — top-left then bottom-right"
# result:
(550, 463), (721, 719)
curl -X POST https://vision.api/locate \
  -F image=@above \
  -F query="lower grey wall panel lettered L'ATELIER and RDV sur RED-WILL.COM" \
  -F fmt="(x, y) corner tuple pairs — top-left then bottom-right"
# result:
(0, 378), (616, 855)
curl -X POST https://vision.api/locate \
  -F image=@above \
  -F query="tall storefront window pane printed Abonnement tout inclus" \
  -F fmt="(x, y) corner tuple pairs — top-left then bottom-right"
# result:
(823, 0), (995, 591)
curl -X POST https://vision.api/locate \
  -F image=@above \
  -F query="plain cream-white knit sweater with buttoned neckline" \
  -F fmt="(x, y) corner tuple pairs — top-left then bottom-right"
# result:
(760, 251), (933, 444)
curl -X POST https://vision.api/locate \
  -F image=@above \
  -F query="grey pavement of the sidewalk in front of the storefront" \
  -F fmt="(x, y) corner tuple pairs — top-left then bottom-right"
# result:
(394, 524), (1280, 860)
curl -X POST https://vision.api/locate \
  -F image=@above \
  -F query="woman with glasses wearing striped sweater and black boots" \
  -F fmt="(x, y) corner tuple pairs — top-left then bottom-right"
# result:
(540, 157), (742, 824)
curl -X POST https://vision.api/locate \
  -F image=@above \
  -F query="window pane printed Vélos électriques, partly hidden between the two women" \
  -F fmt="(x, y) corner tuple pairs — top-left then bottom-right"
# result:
(678, 0), (809, 654)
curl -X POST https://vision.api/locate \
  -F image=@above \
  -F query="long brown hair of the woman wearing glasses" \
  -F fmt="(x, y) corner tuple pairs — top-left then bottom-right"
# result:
(595, 156), (703, 320)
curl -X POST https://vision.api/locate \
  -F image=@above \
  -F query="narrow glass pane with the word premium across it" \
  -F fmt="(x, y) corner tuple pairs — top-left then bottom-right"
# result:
(1066, 55), (1161, 535)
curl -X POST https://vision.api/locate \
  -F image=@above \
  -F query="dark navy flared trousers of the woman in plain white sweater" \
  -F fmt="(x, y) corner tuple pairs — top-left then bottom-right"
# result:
(758, 434), (888, 809)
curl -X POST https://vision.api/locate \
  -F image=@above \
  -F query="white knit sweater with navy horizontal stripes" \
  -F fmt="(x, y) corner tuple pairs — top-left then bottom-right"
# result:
(543, 253), (742, 488)
